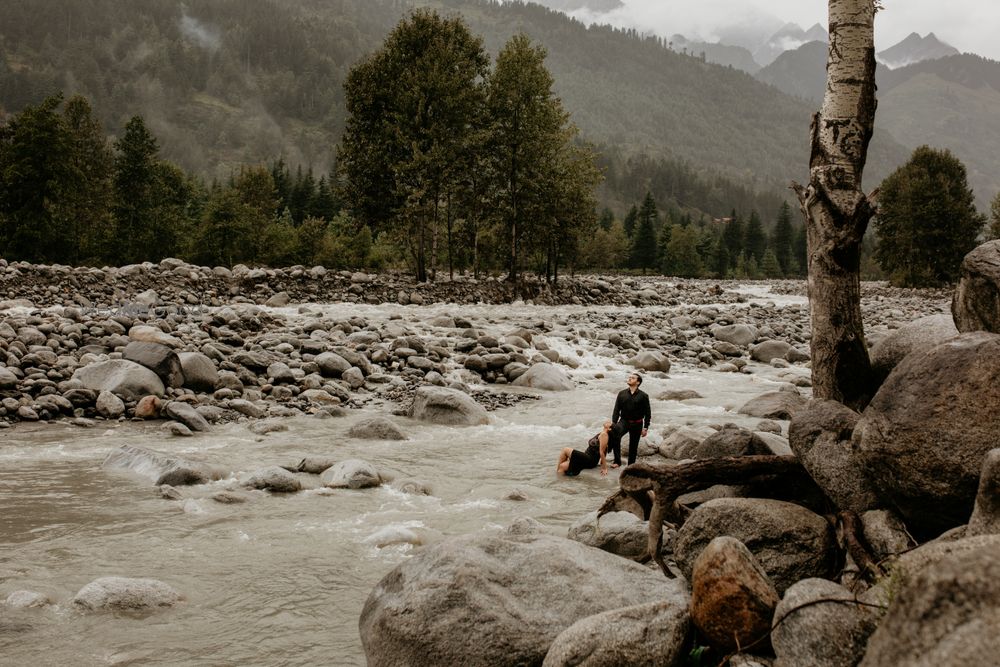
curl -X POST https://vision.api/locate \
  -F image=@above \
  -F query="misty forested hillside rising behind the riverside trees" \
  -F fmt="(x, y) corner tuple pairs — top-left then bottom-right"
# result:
(0, 0), (906, 209)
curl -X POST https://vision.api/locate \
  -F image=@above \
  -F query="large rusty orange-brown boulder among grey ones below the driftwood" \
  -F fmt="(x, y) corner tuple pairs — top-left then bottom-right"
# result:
(691, 536), (779, 654)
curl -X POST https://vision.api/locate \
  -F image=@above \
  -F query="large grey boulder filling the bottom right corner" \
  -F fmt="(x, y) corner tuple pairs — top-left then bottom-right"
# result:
(861, 538), (1000, 667)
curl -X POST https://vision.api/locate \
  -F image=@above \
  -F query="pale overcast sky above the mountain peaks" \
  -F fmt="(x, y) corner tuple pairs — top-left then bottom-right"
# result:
(579, 0), (1000, 60)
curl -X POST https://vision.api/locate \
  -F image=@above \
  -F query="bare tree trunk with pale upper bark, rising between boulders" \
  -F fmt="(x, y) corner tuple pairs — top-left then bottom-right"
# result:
(792, 0), (876, 410)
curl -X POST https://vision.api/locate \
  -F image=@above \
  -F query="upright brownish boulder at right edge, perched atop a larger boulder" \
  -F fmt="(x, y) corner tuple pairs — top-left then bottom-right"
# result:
(951, 239), (1000, 333)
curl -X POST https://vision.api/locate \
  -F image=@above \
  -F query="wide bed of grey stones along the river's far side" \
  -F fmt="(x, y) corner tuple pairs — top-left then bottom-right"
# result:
(0, 259), (948, 434)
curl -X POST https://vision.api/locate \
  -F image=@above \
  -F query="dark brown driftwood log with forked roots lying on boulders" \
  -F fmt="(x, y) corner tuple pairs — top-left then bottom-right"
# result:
(597, 456), (824, 578)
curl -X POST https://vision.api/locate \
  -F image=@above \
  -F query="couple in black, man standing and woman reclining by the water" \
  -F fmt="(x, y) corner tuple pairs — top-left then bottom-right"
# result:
(556, 373), (651, 476)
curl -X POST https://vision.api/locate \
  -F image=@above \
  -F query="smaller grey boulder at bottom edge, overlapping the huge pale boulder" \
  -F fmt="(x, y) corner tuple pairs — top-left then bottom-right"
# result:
(542, 601), (691, 667)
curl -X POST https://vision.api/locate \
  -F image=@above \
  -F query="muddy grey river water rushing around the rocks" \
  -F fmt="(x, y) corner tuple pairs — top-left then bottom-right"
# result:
(0, 298), (808, 665)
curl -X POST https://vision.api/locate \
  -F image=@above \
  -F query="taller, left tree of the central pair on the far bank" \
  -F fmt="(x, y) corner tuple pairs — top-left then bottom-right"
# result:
(338, 10), (489, 280)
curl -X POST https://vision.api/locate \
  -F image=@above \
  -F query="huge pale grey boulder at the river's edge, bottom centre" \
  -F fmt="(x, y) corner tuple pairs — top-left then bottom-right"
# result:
(359, 522), (689, 667)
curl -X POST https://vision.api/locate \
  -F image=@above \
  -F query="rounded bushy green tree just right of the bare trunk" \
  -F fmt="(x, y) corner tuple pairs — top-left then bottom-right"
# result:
(874, 146), (986, 287)
